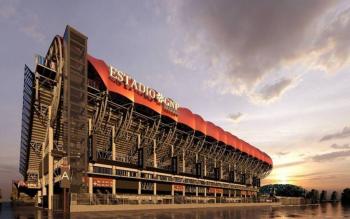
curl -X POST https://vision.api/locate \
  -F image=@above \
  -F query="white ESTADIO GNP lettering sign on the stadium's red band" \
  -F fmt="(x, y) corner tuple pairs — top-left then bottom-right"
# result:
(109, 66), (179, 114)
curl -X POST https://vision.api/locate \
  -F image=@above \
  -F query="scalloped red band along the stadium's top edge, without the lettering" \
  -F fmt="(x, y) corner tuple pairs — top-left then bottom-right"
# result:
(88, 55), (272, 165)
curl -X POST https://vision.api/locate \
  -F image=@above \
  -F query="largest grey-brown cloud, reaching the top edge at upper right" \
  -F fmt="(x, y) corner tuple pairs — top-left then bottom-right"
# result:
(168, 0), (350, 102)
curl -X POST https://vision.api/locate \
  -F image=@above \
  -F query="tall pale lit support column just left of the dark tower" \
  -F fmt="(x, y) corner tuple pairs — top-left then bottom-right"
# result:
(48, 106), (53, 210)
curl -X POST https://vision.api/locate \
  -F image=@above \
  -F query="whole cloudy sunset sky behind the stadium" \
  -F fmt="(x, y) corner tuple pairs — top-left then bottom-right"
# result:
(0, 0), (350, 199)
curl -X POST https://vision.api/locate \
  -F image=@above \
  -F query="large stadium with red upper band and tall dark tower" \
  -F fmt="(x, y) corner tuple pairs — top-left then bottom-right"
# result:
(20, 26), (273, 211)
